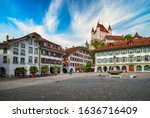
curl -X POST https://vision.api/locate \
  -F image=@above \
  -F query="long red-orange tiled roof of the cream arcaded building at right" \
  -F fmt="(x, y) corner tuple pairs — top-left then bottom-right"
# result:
(95, 37), (150, 52)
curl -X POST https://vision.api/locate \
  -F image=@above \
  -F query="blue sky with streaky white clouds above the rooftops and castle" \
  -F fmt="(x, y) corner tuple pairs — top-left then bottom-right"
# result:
(0, 0), (150, 47)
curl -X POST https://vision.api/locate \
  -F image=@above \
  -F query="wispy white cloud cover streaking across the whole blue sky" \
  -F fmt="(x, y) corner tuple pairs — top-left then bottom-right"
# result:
(0, 0), (150, 47)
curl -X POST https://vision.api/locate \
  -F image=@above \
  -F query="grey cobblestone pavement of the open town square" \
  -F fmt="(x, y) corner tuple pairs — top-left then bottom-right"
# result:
(0, 73), (150, 101)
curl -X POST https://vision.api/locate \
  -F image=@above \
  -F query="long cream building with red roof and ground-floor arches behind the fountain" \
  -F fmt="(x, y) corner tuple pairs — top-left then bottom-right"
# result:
(95, 38), (150, 72)
